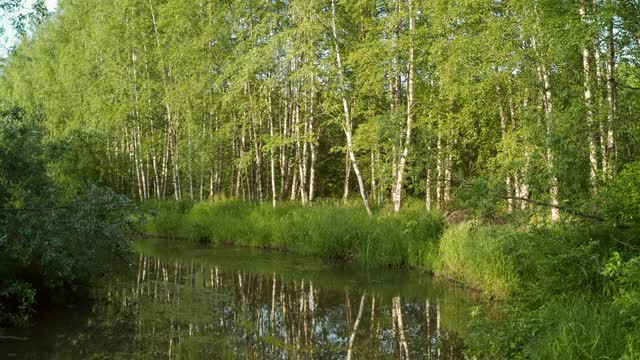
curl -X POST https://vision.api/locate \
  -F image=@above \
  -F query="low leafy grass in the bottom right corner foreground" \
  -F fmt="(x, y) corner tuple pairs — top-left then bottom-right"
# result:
(466, 294), (640, 360)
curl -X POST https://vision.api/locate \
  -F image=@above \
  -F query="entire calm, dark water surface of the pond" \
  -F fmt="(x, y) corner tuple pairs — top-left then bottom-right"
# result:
(0, 240), (484, 359)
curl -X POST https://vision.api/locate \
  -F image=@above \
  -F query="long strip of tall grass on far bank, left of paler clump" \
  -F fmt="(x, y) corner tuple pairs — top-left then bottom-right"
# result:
(143, 201), (445, 270)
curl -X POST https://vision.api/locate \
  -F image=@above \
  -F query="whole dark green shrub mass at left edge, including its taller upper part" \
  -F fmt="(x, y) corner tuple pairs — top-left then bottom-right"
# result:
(0, 110), (139, 323)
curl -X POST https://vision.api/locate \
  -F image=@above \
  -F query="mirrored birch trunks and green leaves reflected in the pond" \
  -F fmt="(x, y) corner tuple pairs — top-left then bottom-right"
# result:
(5, 248), (476, 359)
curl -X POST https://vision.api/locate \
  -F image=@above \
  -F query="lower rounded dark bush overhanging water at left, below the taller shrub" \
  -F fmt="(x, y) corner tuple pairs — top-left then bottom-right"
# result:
(0, 187), (135, 313)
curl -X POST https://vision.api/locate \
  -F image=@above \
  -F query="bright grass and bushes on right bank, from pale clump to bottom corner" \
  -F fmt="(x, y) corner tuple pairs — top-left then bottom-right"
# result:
(452, 224), (640, 359)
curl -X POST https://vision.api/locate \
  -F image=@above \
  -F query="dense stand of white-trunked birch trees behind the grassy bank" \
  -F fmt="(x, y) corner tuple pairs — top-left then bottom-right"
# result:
(0, 0), (640, 220)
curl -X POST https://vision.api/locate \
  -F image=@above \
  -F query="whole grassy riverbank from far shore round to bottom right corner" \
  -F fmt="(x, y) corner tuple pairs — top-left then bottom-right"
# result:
(142, 201), (640, 359)
